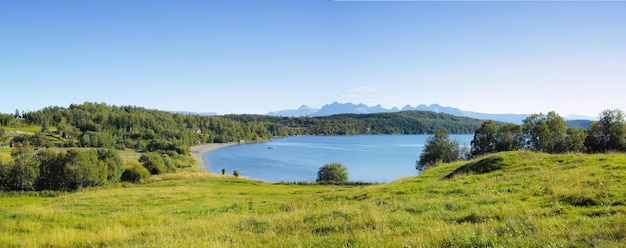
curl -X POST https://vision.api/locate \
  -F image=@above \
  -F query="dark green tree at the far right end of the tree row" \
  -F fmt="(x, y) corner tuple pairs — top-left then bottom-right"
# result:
(585, 109), (626, 152)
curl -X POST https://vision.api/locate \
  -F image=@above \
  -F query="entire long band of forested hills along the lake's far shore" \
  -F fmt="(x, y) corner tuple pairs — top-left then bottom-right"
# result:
(0, 102), (482, 153)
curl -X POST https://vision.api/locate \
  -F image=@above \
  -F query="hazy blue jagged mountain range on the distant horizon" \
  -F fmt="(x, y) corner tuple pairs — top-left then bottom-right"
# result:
(266, 102), (593, 124)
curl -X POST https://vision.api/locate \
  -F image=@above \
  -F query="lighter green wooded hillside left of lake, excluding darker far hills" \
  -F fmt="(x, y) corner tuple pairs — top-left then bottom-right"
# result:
(24, 102), (278, 150)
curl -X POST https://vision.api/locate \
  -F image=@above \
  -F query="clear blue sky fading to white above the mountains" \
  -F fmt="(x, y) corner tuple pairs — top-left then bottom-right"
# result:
(0, 0), (626, 116)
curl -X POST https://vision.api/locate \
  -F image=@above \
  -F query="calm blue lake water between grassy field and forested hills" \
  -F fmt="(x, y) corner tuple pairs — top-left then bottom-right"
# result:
(205, 135), (474, 182)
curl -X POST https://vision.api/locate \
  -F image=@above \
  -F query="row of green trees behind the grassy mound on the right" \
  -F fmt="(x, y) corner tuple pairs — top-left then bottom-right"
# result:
(416, 109), (626, 171)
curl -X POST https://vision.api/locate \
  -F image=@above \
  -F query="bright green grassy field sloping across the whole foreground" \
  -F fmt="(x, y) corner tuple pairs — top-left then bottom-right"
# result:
(0, 152), (626, 247)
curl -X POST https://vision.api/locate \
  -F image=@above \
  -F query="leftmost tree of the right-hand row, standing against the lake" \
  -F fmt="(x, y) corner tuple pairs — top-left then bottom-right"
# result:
(415, 129), (463, 171)
